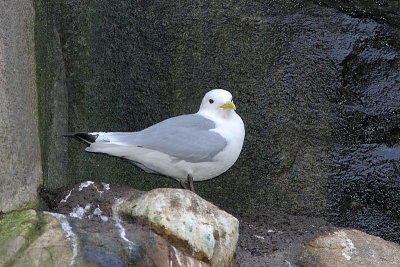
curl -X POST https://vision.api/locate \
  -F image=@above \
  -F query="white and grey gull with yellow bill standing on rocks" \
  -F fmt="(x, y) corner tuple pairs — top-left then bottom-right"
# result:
(64, 89), (245, 191)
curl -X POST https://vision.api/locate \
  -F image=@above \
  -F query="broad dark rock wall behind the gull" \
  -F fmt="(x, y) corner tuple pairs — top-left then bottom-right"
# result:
(38, 0), (400, 243)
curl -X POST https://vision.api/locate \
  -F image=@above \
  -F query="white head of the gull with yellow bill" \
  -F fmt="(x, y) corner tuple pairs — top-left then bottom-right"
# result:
(199, 89), (236, 117)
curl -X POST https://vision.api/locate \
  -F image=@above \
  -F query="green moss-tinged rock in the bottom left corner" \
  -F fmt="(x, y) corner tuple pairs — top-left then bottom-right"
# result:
(0, 210), (88, 267)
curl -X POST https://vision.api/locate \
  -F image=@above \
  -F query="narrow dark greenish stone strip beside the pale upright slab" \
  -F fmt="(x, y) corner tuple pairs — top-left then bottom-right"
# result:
(35, 0), (69, 188)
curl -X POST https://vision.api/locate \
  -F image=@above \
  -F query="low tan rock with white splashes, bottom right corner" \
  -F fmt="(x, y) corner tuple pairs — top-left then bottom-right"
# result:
(300, 229), (400, 267)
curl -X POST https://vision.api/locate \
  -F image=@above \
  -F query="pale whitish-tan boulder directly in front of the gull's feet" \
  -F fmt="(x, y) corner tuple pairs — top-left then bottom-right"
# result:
(113, 188), (239, 267)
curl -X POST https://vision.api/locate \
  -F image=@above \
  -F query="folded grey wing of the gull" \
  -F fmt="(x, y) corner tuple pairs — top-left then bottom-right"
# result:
(101, 114), (227, 162)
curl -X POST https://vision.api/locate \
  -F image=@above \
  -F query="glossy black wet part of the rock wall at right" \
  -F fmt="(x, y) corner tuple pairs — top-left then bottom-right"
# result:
(329, 19), (400, 242)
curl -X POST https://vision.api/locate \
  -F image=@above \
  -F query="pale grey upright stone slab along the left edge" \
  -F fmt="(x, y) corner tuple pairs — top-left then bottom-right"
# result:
(0, 1), (42, 212)
